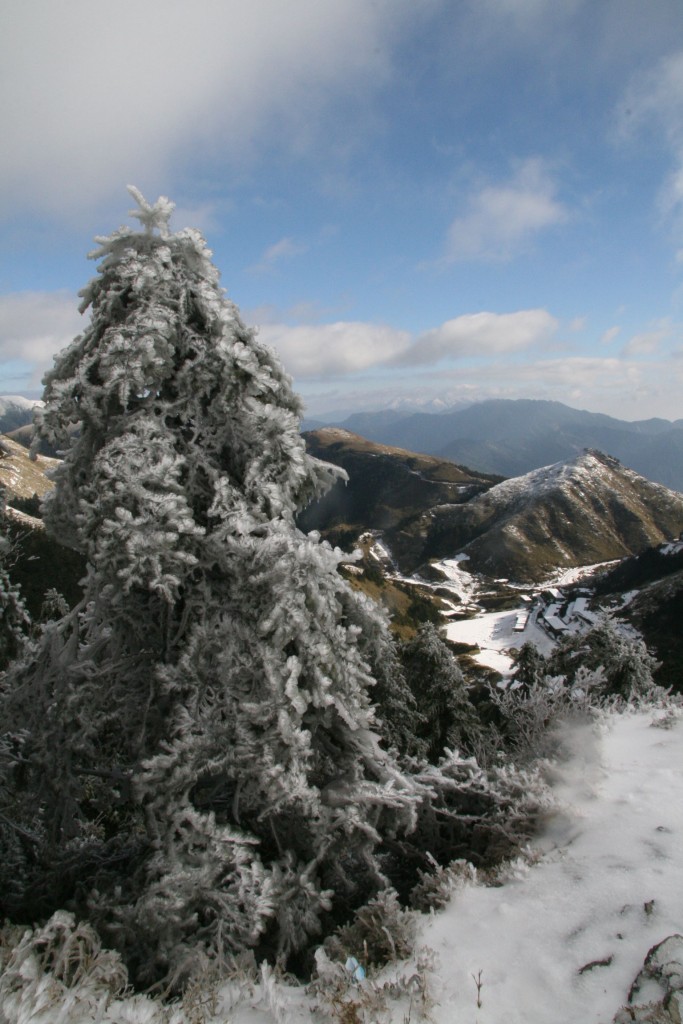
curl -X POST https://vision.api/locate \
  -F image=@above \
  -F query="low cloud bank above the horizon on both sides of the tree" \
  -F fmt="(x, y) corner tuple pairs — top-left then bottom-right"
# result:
(0, 292), (683, 419)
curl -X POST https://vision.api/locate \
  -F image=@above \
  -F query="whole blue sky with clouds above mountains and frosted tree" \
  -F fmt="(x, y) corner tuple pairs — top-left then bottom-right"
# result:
(0, 0), (683, 419)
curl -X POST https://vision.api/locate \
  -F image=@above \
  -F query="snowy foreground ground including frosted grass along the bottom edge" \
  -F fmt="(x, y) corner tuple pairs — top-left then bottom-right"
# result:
(0, 711), (683, 1024)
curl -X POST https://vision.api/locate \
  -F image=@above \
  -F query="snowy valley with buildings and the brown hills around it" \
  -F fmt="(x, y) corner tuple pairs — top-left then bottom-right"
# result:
(302, 428), (683, 690)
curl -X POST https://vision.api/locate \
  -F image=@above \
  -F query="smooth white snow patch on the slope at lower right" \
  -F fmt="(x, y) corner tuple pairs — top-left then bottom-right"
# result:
(422, 713), (683, 1024)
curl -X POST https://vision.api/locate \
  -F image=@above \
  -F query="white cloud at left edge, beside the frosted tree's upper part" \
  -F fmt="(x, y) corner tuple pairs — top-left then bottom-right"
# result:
(0, 292), (83, 387)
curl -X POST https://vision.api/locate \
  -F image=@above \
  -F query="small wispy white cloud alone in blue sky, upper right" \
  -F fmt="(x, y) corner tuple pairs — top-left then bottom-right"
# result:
(445, 158), (569, 262)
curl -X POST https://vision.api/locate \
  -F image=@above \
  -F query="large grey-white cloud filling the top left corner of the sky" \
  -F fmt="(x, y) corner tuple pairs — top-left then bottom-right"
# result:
(0, 0), (416, 213)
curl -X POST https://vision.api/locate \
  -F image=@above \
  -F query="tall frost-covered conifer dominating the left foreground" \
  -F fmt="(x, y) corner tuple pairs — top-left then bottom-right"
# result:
(0, 189), (415, 981)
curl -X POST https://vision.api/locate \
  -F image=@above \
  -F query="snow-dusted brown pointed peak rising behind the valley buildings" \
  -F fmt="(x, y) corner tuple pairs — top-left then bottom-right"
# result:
(425, 449), (683, 582)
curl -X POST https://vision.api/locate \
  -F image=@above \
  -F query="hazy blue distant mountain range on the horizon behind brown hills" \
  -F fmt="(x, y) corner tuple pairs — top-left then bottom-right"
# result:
(321, 399), (683, 490)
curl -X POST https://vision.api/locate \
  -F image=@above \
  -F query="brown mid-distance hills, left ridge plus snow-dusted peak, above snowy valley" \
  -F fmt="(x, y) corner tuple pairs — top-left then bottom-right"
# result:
(301, 428), (683, 582)
